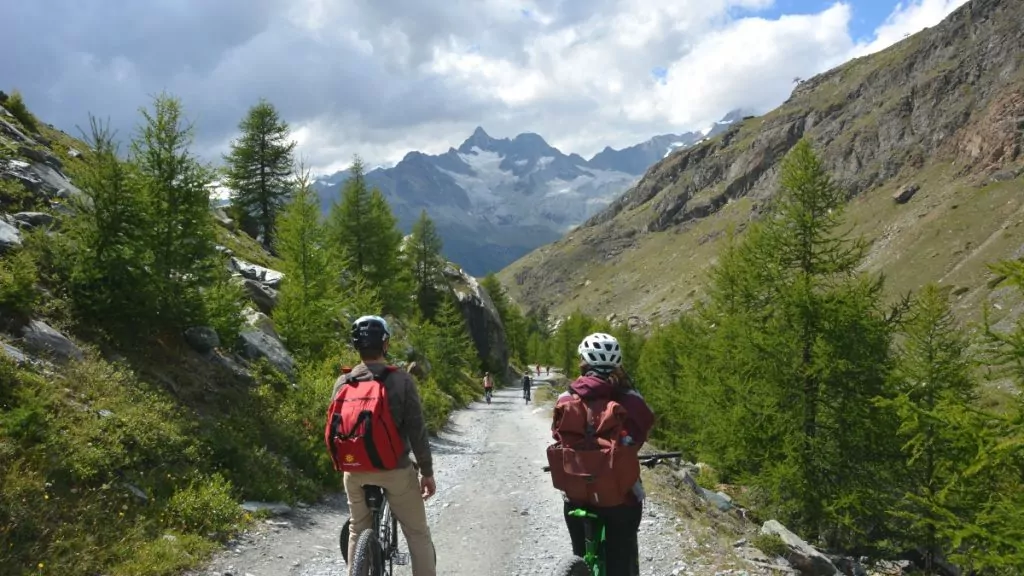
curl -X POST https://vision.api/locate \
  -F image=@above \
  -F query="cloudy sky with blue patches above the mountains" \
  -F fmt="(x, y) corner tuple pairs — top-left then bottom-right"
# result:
(0, 0), (967, 172)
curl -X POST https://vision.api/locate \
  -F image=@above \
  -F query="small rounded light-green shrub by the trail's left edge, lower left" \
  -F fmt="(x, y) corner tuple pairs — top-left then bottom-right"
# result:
(167, 474), (242, 536)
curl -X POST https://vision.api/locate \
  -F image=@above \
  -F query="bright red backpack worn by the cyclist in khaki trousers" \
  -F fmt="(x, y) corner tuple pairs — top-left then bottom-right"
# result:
(324, 366), (406, 472)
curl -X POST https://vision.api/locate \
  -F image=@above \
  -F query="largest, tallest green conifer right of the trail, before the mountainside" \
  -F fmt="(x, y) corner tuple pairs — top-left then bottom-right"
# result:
(706, 139), (898, 544)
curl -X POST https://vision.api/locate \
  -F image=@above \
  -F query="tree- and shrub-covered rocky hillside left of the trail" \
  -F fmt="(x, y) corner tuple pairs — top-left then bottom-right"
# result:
(0, 92), (508, 576)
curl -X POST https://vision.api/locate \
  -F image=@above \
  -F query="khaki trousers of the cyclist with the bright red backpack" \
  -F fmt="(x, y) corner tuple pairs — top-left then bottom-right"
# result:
(345, 465), (437, 576)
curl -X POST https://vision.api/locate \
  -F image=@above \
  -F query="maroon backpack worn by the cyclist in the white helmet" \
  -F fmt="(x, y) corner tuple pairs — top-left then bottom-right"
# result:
(547, 394), (640, 506)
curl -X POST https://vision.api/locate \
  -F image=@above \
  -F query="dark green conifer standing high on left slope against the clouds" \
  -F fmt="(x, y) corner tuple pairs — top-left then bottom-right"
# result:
(224, 99), (296, 249)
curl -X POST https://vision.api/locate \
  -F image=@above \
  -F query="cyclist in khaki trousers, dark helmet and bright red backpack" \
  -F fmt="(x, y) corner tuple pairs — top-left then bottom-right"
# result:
(325, 316), (437, 576)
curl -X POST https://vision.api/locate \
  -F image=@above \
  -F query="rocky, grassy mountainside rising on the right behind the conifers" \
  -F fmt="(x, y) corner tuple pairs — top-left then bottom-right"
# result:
(499, 0), (1024, 322)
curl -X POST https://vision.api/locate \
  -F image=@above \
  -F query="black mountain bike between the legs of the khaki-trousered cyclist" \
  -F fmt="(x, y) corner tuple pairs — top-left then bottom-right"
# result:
(338, 486), (409, 576)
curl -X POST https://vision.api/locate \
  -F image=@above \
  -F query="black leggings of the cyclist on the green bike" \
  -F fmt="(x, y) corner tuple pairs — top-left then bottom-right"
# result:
(563, 502), (643, 576)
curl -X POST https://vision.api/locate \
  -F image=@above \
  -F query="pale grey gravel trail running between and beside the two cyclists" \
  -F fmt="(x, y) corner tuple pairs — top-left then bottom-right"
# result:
(194, 388), (742, 576)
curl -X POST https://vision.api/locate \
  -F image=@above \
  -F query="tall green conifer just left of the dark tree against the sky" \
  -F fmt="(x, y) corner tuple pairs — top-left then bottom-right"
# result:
(131, 94), (215, 328)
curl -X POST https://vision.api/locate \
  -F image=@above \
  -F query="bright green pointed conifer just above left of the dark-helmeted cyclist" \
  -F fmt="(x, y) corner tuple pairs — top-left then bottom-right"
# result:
(273, 163), (342, 358)
